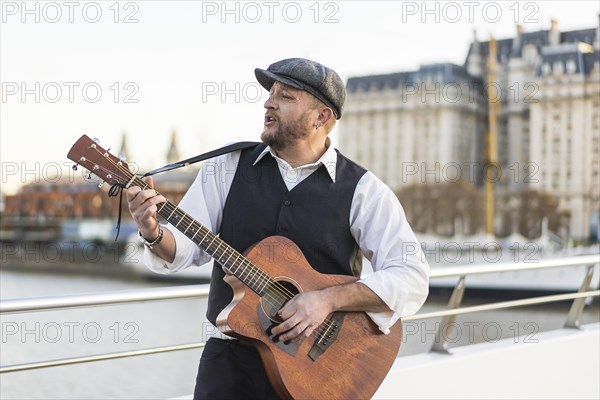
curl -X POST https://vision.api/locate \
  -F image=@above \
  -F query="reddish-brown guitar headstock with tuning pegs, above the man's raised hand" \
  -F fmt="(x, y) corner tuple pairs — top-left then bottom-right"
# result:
(67, 135), (134, 185)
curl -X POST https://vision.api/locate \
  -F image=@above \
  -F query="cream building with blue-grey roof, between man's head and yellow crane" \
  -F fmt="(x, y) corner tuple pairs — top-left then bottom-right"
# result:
(340, 64), (485, 189)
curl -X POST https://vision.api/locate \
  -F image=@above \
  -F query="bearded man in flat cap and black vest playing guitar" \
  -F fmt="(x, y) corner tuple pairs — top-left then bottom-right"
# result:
(127, 58), (428, 399)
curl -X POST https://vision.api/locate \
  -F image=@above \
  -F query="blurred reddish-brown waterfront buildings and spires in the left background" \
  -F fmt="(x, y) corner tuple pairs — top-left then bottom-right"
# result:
(1, 131), (198, 242)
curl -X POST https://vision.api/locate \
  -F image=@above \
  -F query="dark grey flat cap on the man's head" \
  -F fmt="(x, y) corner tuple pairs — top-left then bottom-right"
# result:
(254, 58), (346, 119)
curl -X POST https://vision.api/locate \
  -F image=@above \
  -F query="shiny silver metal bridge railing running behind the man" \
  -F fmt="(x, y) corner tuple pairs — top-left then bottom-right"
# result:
(0, 254), (600, 374)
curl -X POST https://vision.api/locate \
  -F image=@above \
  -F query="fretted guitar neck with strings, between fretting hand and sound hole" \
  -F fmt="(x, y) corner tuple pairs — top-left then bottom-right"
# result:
(130, 177), (274, 296)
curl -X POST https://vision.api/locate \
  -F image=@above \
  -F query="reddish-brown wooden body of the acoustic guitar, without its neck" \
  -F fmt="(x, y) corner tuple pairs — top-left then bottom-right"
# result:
(217, 236), (402, 399)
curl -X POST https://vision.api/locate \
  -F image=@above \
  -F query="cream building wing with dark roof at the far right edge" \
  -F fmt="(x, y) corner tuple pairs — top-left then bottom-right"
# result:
(528, 42), (600, 237)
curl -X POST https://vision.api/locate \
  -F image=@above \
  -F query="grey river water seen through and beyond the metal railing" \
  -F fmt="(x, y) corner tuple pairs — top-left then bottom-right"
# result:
(0, 267), (600, 399)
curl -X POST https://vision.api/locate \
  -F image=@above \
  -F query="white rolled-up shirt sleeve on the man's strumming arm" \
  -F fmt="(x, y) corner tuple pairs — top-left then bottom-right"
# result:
(350, 172), (429, 333)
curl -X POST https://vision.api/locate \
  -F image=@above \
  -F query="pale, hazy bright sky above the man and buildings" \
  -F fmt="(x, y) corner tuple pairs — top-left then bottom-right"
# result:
(0, 0), (600, 194)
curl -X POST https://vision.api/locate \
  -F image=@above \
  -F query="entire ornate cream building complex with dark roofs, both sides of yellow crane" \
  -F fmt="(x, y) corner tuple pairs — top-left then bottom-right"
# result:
(340, 21), (600, 239)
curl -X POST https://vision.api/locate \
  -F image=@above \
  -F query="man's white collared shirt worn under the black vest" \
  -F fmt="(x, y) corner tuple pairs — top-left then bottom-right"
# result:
(144, 141), (429, 333)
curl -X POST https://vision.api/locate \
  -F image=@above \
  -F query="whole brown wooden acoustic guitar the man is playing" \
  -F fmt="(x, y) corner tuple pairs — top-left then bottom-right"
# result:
(67, 135), (402, 399)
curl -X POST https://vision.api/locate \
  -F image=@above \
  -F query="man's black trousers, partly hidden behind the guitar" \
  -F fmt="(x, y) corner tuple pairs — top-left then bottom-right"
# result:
(194, 338), (279, 400)
